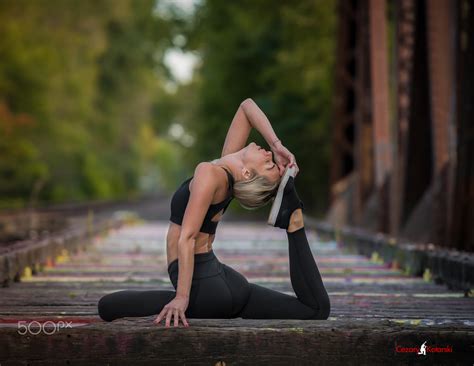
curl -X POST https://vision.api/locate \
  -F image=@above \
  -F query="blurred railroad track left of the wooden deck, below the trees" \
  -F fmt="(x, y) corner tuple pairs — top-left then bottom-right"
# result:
(0, 196), (168, 287)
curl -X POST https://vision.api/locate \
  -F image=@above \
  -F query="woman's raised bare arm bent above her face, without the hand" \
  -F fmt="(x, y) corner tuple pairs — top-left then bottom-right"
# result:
(221, 98), (278, 156)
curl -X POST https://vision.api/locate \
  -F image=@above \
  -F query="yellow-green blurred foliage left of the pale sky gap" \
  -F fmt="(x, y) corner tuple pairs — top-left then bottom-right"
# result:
(0, 0), (182, 206)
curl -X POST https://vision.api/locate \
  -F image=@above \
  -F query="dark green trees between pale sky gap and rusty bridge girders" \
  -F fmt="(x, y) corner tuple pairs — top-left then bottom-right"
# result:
(176, 0), (336, 213)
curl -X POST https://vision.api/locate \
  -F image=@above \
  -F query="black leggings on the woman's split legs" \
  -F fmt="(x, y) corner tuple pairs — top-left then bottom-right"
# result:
(98, 227), (330, 321)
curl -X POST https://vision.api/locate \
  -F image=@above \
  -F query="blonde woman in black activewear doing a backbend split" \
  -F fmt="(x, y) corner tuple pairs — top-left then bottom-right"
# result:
(98, 98), (330, 327)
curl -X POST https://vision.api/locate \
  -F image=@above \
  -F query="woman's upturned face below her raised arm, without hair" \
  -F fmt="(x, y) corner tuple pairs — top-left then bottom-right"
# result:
(243, 142), (280, 182)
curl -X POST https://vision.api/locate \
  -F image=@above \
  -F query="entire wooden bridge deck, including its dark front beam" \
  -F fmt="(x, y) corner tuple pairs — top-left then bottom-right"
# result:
(0, 222), (474, 365)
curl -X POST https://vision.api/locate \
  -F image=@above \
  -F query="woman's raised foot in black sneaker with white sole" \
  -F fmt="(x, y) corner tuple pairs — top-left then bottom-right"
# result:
(267, 167), (304, 230)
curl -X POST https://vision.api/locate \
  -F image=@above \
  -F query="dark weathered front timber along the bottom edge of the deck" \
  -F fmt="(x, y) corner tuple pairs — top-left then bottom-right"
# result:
(0, 317), (474, 365)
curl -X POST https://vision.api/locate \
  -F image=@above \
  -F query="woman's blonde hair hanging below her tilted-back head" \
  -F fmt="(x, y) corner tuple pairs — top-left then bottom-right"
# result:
(212, 159), (281, 210)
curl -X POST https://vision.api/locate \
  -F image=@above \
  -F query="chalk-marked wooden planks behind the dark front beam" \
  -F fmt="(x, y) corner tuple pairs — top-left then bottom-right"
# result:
(0, 222), (474, 327)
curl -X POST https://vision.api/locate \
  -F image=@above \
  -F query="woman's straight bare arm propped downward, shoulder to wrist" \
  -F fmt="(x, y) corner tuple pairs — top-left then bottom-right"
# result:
(176, 163), (218, 298)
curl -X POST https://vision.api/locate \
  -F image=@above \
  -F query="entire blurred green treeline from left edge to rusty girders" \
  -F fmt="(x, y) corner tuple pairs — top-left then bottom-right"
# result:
(0, 0), (335, 212)
